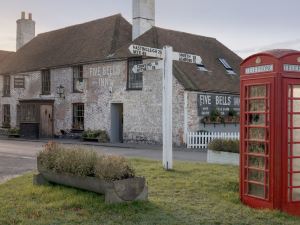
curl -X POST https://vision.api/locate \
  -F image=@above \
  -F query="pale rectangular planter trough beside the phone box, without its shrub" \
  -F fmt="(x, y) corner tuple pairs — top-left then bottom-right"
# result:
(207, 149), (240, 166)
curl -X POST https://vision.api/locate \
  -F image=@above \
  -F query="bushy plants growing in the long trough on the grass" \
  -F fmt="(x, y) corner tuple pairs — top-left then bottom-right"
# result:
(38, 142), (135, 181)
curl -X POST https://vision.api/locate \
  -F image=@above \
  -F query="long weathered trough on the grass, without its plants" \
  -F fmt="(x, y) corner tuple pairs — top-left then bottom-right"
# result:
(33, 165), (148, 204)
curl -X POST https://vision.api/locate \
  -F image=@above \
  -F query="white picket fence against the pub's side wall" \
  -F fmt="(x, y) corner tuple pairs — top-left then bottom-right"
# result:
(187, 132), (240, 149)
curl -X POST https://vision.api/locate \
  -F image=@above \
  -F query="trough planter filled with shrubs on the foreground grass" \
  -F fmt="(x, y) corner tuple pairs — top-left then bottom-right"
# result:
(33, 142), (148, 203)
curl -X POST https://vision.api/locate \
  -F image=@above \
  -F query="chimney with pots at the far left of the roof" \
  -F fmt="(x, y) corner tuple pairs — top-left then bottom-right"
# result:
(16, 12), (35, 51)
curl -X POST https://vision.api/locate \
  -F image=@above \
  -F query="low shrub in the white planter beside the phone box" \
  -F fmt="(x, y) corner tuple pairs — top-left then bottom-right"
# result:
(208, 139), (240, 153)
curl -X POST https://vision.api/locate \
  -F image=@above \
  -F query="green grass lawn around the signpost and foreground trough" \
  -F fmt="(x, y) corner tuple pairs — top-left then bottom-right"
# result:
(0, 159), (300, 225)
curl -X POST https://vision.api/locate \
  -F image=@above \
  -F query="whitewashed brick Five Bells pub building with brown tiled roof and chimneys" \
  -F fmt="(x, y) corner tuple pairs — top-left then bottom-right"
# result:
(0, 0), (242, 145)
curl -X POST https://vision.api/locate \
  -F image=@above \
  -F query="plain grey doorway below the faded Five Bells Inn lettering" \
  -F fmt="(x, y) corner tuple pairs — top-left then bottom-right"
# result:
(110, 103), (123, 143)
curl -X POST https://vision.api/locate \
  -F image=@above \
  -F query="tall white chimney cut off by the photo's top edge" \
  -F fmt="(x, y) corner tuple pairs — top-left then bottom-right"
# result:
(132, 0), (155, 40)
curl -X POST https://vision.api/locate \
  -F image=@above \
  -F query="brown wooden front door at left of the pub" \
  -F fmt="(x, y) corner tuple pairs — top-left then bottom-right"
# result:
(40, 105), (53, 138)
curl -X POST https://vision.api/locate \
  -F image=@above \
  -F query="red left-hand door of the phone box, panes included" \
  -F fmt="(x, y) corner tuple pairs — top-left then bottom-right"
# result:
(241, 78), (274, 207)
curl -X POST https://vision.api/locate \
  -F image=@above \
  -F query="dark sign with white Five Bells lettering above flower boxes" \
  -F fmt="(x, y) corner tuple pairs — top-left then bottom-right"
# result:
(198, 93), (240, 116)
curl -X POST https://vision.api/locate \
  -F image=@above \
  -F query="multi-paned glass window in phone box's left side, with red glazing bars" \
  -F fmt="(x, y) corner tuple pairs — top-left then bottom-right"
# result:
(243, 85), (270, 199)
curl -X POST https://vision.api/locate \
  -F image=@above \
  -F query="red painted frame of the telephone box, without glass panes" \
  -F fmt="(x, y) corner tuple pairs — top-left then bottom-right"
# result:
(240, 50), (300, 215)
